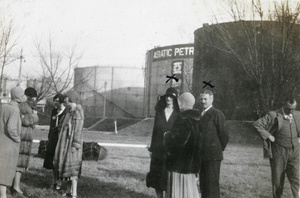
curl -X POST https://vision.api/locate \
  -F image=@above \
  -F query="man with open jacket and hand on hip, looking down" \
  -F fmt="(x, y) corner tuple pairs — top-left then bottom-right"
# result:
(253, 98), (300, 198)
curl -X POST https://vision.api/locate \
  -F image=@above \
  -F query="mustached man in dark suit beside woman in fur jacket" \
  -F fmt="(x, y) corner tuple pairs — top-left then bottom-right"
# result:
(199, 90), (229, 198)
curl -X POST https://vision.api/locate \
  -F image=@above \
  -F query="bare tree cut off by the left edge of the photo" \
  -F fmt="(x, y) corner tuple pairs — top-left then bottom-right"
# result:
(0, 17), (17, 95)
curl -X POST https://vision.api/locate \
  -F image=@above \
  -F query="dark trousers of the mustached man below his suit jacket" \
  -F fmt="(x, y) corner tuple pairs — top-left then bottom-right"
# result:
(200, 160), (221, 198)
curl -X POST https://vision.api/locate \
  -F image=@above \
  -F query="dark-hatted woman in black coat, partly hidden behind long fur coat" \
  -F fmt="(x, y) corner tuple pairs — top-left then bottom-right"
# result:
(43, 93), (70, 190)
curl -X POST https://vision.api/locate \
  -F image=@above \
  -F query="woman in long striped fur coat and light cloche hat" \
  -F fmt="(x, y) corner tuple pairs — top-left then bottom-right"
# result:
(53, 90), (84, 198)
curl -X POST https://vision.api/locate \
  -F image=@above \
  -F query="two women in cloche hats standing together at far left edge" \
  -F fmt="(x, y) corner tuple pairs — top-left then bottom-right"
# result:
(0, 87), (38, 198)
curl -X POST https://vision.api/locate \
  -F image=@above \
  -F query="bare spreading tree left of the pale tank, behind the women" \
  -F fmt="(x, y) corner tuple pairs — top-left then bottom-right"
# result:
(35, 35), (82, 100)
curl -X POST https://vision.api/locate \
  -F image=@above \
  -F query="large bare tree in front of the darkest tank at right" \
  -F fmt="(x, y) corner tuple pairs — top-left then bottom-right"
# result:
(196, 0), (300, 114)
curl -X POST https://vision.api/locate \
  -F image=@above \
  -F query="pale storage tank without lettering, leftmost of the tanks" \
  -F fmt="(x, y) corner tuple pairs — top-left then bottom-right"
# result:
(74, 66), (144, 117)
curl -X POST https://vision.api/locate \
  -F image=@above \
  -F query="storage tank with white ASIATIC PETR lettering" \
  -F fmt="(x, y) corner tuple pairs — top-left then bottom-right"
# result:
(144, 43), (194, 117)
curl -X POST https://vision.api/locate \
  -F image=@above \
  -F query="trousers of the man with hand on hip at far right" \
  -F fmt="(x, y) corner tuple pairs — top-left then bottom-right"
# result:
(270, 143), (299, 198)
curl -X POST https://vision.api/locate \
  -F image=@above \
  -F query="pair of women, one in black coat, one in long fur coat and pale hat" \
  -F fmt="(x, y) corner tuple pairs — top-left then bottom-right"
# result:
(43, 90), (84, 198)
